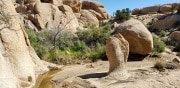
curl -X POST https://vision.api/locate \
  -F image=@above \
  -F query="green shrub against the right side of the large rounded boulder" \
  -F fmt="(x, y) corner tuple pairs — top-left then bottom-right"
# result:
(153, 35), (166, 54)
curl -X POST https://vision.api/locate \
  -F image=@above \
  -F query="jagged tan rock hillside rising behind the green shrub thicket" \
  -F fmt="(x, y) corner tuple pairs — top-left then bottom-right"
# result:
(14, 0), (111, 32)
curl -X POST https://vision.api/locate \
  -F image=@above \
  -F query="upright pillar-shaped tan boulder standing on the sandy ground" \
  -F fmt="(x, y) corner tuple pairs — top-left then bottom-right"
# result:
(106, 33), (129, 80)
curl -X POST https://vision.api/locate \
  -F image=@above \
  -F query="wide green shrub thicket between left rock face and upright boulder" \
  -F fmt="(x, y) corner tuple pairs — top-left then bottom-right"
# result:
(26, 24), (111, 64)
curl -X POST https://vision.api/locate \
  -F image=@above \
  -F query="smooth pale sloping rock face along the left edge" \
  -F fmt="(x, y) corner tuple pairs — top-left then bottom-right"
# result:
(0, 0), (47, 88)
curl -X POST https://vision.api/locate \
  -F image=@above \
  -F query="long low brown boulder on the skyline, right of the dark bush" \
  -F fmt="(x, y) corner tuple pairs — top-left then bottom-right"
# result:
(140, 6), (160, 14)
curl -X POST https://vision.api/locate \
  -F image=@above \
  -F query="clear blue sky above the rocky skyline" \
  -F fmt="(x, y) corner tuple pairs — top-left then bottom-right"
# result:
(93, 0), (180, 15)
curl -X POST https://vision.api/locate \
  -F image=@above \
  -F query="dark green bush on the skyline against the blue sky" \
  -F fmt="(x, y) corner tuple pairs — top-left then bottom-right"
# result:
(115, 8), (131, 21)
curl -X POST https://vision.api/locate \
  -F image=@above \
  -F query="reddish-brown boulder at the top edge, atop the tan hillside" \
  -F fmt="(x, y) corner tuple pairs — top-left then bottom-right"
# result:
(62, 0), (82, 13)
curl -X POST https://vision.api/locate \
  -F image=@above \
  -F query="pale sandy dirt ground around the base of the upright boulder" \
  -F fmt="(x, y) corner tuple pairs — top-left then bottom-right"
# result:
(36, 54), (180, 88)
